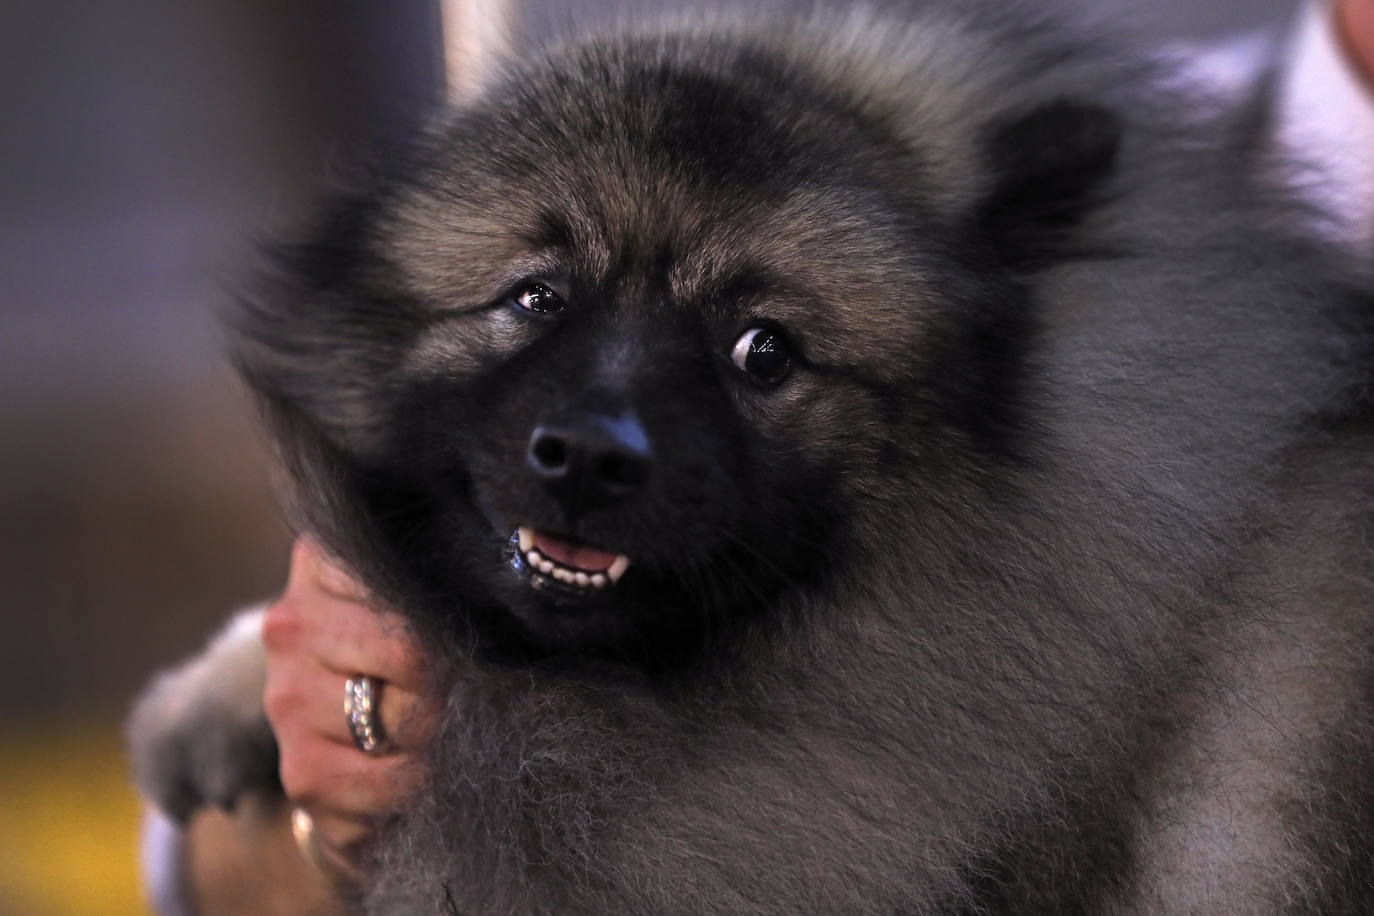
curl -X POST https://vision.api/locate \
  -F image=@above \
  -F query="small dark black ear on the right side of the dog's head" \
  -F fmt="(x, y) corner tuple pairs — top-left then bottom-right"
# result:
(978, 99), (1123, 261)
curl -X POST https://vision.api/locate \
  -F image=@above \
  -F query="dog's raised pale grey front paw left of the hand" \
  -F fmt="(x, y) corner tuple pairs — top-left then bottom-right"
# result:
(128, 610), (282, 821)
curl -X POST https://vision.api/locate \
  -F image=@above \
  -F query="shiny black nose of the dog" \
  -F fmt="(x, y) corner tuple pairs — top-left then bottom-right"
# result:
(526, 411), (653, 511)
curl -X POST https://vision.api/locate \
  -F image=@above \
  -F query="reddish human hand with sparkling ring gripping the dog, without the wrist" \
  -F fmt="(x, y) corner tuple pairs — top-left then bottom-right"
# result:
(262, 540), (440, 875)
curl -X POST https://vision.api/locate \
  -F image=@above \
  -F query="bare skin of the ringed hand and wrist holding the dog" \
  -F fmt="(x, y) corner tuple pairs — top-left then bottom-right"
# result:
(181, 540), (437, 916)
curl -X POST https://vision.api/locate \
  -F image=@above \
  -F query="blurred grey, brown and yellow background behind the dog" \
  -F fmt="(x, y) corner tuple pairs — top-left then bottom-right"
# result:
(0, 0), (1294, 916)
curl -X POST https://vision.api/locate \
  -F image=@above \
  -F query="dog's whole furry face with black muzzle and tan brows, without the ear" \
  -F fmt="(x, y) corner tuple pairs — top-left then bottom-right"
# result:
(250, 35), (1115, 663)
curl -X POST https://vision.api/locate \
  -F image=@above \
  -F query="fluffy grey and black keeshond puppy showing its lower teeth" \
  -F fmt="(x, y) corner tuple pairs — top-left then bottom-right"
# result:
(136, 5), (1374, 915)
